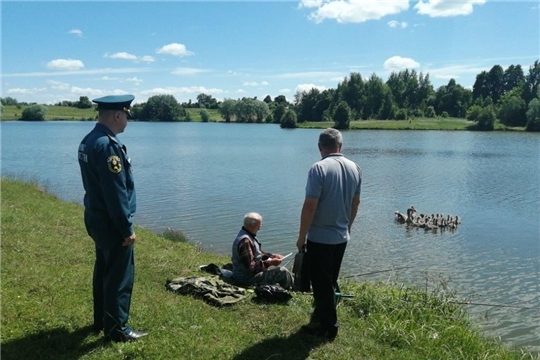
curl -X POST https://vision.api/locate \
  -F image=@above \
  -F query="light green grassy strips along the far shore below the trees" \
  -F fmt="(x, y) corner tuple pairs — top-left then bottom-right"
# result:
(2, 105), (525, 131)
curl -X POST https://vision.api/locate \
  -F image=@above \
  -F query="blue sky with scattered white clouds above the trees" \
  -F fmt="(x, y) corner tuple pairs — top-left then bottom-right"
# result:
(0, 0), (540, 104)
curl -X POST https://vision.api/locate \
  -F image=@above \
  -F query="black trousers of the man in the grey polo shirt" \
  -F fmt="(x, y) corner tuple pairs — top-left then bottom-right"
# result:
(307, 239), (347, 329)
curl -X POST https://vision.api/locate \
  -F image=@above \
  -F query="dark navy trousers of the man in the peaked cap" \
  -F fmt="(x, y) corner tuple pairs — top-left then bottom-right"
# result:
(91, 229), (135, 340)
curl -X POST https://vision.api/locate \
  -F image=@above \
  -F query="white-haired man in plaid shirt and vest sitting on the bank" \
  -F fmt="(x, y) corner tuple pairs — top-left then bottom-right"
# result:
(231, 213), (293, 289)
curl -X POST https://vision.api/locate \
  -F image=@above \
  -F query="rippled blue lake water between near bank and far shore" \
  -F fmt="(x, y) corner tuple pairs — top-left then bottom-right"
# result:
(1, 122), (540, 351)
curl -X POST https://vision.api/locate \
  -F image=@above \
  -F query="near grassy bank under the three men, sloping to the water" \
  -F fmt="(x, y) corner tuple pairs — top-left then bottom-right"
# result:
(1, 177), (539, 360)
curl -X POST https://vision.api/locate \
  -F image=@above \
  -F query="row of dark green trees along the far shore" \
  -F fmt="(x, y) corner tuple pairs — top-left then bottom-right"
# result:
(1, 60), (540, 131)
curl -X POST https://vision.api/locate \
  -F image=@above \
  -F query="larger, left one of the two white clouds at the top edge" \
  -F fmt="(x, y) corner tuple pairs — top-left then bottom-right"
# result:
(301, 0), (409, 23)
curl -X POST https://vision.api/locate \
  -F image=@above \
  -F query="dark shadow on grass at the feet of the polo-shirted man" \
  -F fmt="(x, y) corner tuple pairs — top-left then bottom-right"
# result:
(233, 331), (325, 360)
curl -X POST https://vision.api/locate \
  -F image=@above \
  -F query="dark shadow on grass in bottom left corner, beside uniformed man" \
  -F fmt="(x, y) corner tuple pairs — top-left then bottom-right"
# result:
(1, 326), (103, 360)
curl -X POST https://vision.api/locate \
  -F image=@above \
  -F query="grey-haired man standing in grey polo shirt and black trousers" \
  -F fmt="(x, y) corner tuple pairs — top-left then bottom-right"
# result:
(296, 129), (362, 340)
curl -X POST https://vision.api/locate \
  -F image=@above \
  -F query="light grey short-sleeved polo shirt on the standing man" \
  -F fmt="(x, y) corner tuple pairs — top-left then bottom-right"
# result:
(306, 154), (362, 244)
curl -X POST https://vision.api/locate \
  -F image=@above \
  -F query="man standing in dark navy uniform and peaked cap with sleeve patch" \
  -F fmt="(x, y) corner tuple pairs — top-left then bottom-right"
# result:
(79, 95), (147, 342)
